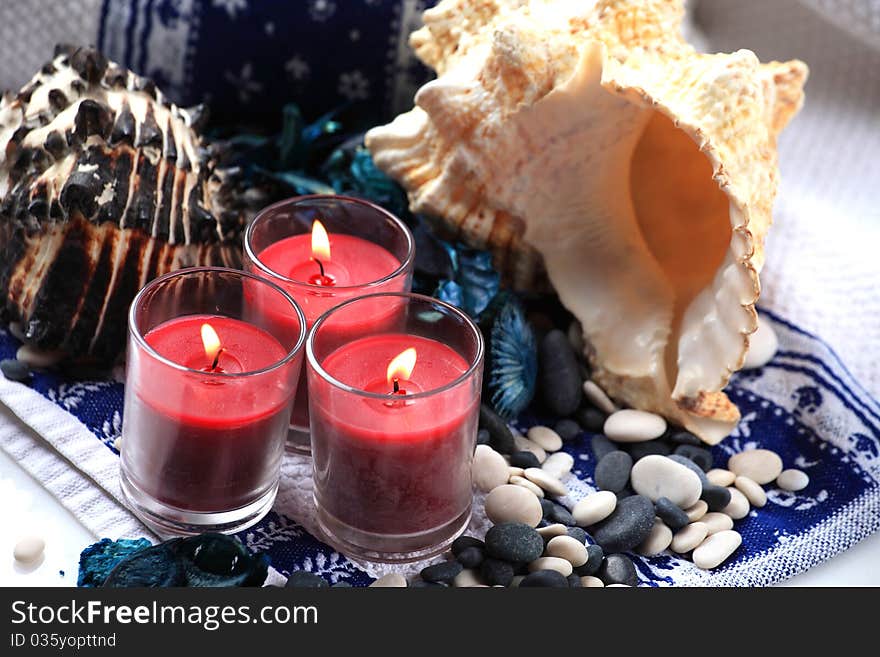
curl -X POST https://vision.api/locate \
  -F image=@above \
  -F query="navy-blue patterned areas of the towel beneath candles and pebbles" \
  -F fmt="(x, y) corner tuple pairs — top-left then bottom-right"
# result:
(0, 312), (880, 586)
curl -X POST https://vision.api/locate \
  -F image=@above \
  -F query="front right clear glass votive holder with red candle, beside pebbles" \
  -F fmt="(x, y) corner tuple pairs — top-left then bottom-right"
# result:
(306, 293), (484, 563)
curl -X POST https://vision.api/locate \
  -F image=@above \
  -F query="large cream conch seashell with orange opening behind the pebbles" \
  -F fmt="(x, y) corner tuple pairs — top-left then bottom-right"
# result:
(367, 0), (807, 443)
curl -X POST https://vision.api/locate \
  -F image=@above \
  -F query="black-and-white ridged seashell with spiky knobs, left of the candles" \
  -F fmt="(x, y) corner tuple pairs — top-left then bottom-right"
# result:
(0, 48), (243, 358)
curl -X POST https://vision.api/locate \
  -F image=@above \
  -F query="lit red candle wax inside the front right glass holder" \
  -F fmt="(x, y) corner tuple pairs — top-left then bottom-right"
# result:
(311, 334), (479, 540)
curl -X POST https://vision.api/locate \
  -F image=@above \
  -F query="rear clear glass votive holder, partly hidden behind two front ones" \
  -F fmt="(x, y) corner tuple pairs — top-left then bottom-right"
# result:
(244, 195), (415, 454)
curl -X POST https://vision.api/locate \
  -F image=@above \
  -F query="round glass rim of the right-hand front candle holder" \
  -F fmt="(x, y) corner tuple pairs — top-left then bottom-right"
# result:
(306, 292), (485, 401)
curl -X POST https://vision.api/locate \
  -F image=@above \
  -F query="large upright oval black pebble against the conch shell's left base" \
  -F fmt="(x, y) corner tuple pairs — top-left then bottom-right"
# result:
(538, 329), (583, 417)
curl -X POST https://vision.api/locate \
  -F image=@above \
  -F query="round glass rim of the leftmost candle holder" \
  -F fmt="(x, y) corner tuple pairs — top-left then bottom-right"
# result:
(128, 267), (308, 379)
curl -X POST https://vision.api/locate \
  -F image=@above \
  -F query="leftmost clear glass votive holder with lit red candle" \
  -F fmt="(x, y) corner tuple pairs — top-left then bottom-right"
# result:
(120, 267), (306, 535)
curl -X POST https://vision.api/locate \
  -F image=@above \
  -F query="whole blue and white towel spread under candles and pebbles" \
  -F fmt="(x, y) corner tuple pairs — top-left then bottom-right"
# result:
(0, 312), (880, 586)
